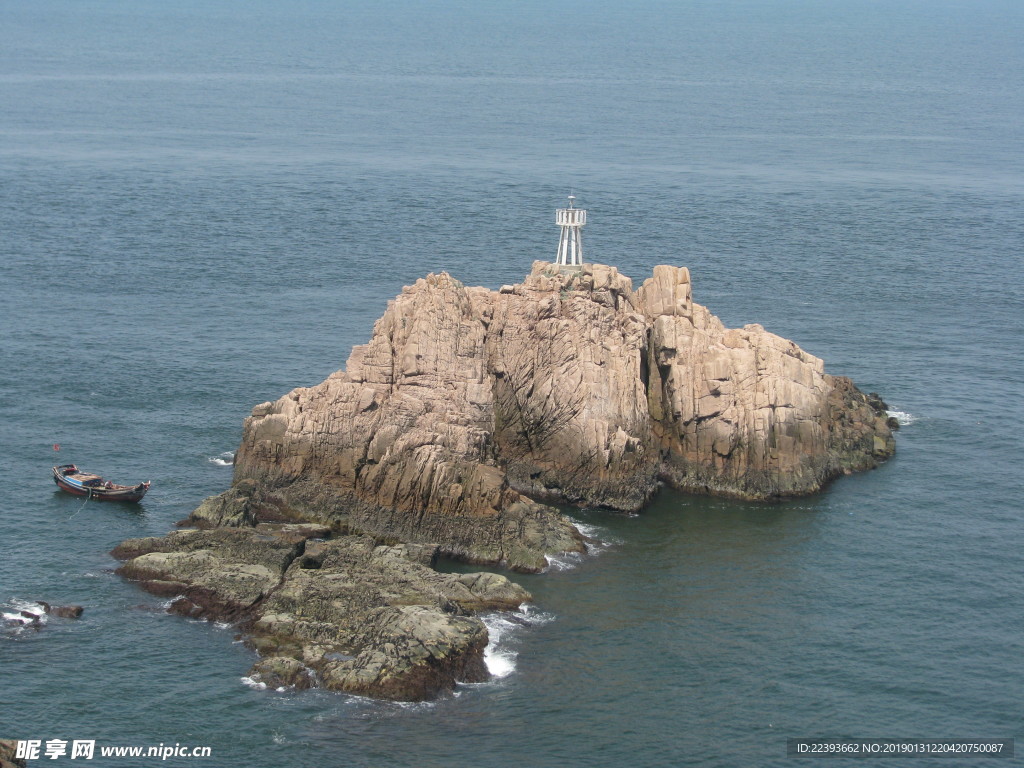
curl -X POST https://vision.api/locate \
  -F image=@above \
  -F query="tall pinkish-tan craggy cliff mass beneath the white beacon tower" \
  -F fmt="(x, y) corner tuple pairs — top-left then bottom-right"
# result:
(220, 262), (894, 570)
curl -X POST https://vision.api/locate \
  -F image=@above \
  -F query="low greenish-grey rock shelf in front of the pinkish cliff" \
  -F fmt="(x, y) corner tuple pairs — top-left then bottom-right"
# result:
(112, 523), (530, 700)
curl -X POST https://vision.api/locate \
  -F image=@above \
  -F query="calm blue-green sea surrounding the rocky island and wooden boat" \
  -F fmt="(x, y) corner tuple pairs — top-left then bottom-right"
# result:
(0, 0), (1024, 768)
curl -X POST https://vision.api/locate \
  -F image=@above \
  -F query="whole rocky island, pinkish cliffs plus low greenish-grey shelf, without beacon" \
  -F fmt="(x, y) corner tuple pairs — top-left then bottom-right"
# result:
(115, 262), (895, 699)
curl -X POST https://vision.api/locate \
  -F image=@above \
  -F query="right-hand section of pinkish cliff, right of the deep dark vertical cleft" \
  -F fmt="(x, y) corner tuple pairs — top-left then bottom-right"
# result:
(638, 266), (895, 499)
